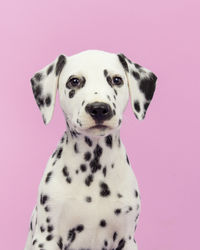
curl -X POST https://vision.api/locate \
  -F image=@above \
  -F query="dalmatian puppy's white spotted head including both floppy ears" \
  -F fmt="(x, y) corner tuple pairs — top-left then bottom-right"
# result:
(31, 50), (157, 136)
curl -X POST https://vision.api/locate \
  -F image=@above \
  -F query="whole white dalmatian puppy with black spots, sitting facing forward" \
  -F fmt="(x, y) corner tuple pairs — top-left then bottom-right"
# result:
(25, 50), (157, 250)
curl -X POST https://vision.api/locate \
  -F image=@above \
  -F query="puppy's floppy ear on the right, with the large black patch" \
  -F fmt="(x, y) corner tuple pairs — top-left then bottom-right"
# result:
(117, 54), (157, 120)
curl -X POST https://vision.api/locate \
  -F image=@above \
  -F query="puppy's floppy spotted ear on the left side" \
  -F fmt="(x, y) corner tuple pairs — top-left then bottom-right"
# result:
(31, 55), (67, 124)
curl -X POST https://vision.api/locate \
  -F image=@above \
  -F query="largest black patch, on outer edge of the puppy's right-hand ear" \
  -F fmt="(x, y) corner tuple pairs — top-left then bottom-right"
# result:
(140, 73), (157, 101)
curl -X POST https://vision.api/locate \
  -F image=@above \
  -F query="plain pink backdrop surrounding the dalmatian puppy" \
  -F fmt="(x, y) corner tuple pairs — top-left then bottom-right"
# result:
(0, 0), (200, 250)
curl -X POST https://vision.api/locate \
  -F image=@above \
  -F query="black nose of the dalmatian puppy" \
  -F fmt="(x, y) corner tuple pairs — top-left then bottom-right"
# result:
(85, 102), (113, 122)
